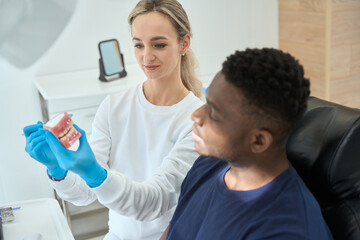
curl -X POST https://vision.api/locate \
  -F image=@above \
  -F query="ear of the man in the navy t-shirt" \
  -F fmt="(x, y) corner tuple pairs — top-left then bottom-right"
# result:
(250, 129), (273, 153)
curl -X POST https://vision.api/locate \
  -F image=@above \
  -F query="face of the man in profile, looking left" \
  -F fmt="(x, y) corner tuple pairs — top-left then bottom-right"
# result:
(191, 72), (252, 162)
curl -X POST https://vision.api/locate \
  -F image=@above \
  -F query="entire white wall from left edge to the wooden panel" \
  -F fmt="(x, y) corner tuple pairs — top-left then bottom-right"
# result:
(0, 0), (278, 203)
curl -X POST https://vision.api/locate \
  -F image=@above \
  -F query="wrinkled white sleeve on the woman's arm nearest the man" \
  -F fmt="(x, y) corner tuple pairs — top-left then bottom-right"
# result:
(91, 132), (199, 221)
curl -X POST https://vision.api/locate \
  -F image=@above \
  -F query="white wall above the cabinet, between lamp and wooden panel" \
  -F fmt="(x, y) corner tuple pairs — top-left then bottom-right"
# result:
(38, 0), (278, 78)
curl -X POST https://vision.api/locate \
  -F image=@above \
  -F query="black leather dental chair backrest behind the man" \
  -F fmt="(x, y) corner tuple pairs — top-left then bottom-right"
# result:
(286, 97), (360, 240)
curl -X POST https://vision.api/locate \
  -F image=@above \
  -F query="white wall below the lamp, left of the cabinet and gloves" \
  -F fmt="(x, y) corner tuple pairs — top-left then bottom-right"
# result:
(0, 58), (53, 203)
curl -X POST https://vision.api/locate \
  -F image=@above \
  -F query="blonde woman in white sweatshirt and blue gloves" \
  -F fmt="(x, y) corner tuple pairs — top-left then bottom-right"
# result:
(24, 0), (202, 239)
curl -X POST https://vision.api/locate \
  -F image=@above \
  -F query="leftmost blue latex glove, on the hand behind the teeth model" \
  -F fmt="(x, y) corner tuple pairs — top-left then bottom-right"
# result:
(23, 121), (67, 179)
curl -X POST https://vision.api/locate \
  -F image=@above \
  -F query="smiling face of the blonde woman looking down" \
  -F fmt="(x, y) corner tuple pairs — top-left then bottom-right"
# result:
(131, 12), (190, 79)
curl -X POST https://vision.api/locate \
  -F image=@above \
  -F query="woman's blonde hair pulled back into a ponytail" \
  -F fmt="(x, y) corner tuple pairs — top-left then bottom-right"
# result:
(128, 0), (202, 97)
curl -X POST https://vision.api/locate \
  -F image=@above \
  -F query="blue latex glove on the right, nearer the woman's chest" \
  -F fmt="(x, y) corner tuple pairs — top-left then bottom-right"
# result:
(45, 124), (107, 187)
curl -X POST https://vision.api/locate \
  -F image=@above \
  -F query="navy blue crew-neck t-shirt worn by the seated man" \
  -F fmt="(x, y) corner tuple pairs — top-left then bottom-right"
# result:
(167, 156), (332, 240)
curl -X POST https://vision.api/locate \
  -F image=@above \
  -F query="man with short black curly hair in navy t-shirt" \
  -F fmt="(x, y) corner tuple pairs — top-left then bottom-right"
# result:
(163, 49), (332, 240)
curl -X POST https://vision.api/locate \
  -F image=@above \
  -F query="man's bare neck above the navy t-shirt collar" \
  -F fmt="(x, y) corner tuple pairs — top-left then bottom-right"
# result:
(224, 153), (290, 191)
